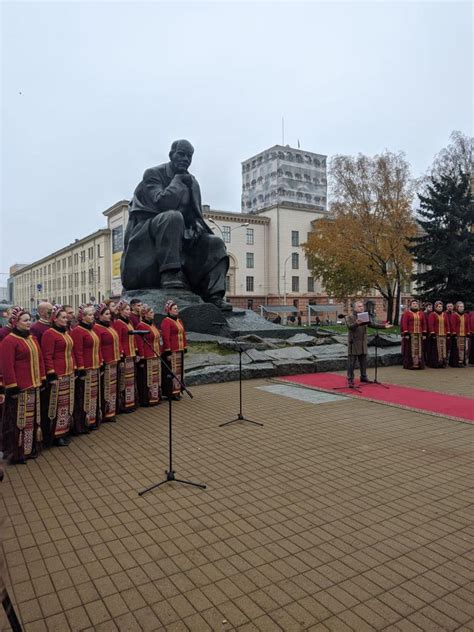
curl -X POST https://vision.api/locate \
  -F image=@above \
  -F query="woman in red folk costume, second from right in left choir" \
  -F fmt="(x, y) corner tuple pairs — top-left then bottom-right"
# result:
(137, 306), (161, 406)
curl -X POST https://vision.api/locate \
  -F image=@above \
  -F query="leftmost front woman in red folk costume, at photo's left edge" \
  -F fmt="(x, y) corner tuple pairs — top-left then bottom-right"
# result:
(0, 307), (46, 463)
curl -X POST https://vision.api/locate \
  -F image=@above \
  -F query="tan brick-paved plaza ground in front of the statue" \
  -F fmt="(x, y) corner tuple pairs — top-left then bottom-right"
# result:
(0, 367), (474, 632)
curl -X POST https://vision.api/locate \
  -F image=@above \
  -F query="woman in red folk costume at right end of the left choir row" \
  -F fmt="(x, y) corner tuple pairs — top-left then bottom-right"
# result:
(160, 301), (187, 398)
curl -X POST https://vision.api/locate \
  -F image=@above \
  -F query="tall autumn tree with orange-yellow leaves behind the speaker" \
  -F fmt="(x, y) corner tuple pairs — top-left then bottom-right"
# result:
(304, 151), (417, 324)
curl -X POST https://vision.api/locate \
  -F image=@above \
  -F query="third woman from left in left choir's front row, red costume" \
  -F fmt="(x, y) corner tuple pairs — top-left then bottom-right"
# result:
(71, 305), (102, 434)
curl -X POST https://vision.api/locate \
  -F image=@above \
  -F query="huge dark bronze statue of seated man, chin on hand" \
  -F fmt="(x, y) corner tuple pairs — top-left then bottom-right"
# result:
(121, 140), (232, 310)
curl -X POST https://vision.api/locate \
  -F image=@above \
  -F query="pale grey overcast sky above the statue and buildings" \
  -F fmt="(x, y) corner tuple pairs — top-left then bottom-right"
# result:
(0, 0), (472, 285)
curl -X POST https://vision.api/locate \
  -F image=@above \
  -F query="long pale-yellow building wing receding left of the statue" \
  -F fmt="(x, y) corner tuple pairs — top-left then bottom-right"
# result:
(10, 228), (111, 311)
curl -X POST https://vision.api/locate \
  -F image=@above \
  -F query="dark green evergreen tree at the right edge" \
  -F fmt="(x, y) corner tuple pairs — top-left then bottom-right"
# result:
(412, 166), (474, 307)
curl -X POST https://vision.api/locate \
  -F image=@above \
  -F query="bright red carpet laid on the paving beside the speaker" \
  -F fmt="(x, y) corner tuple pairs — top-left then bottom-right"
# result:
(279, 373), (474, 424)
